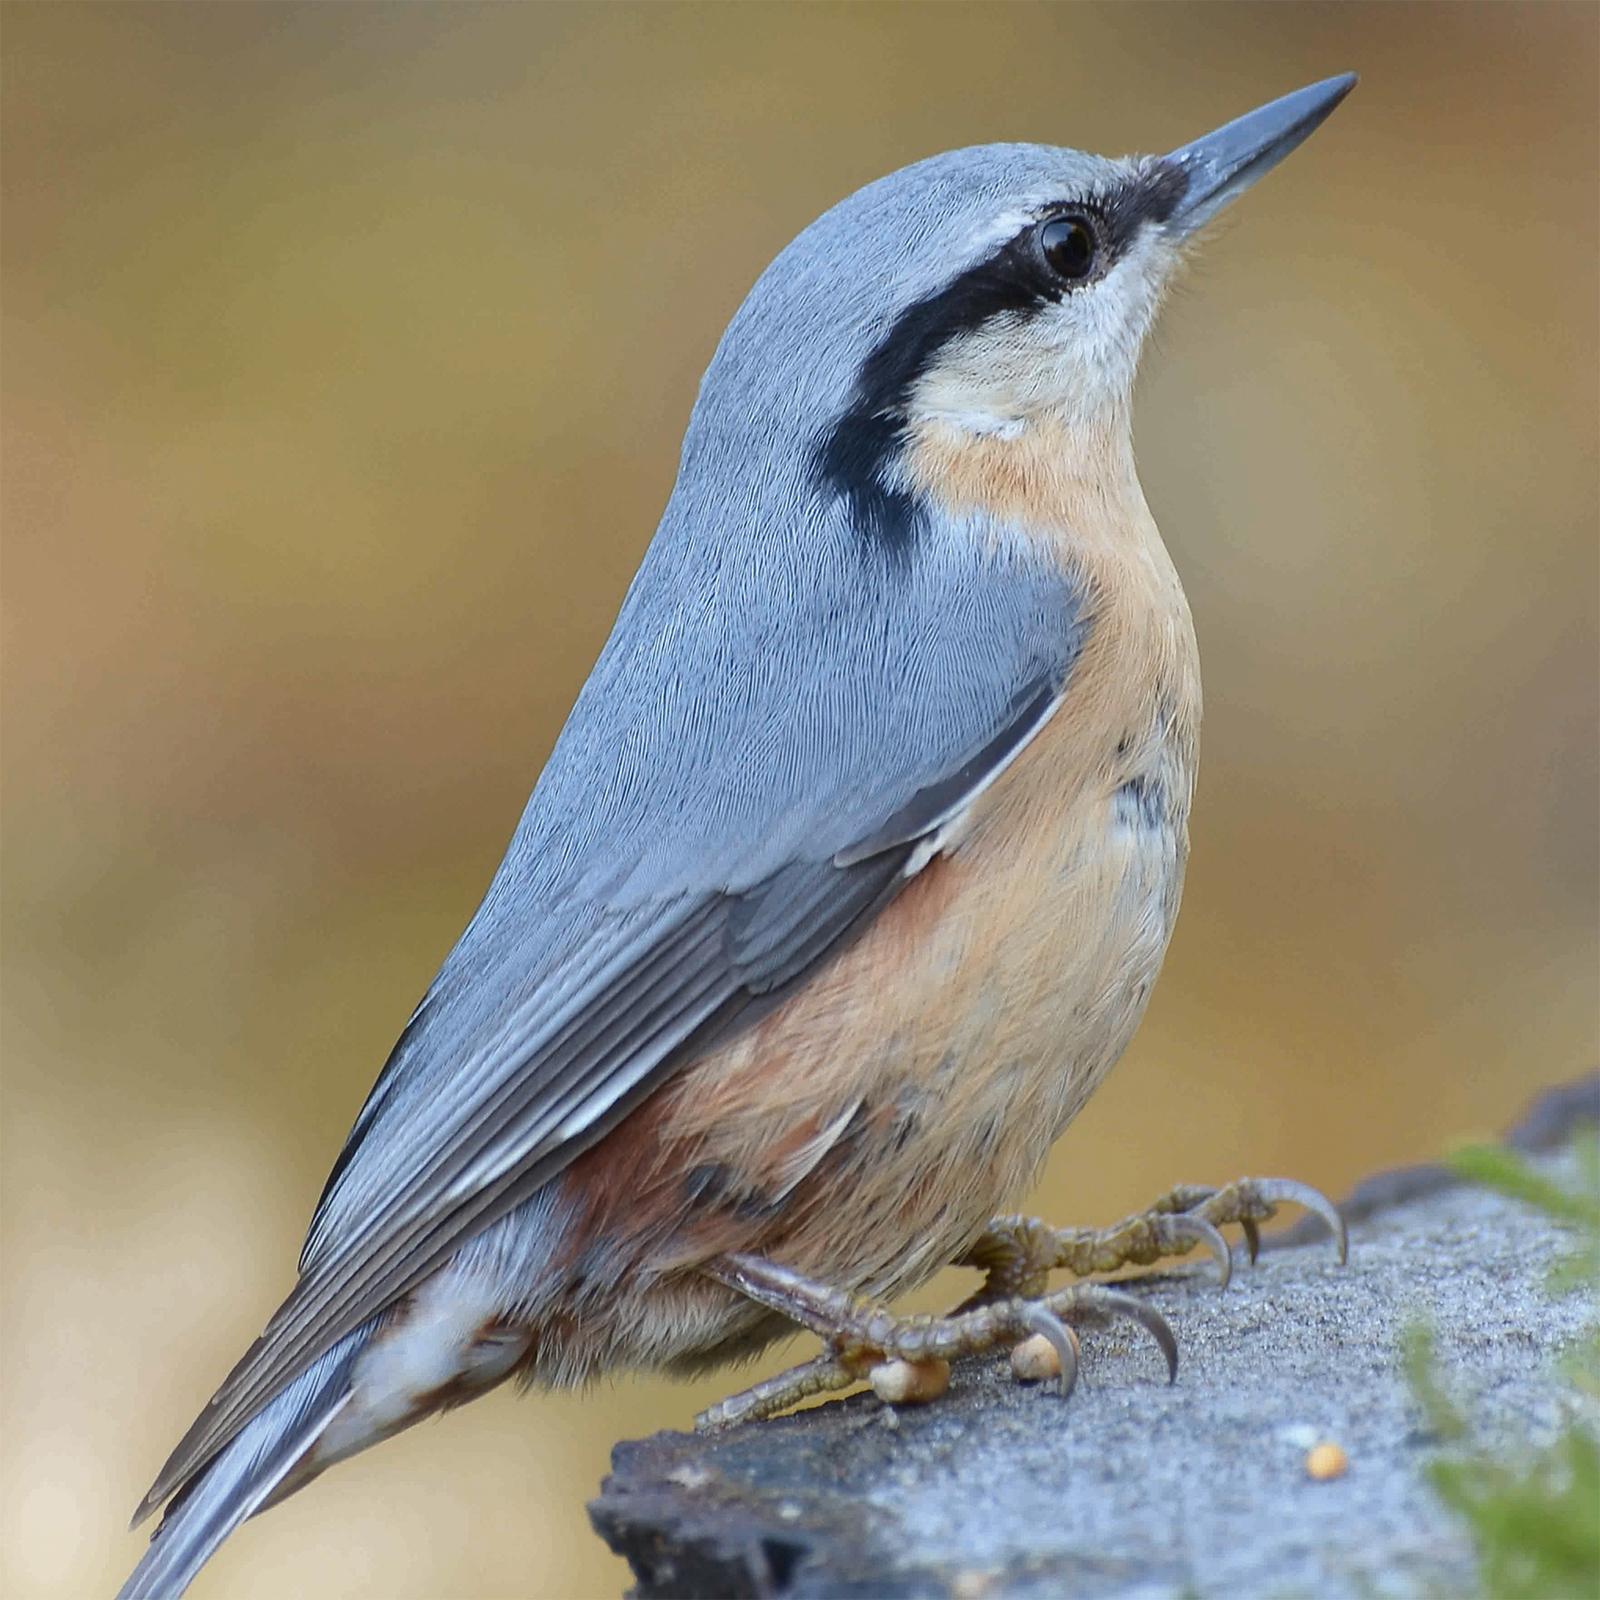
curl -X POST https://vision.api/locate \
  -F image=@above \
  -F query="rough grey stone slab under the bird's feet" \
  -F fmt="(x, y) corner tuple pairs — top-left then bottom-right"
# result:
(590, 1080), (1600, 1600)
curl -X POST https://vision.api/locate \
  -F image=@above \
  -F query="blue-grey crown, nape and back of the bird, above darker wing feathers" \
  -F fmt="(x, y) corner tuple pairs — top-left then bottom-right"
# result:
(310, 146), (1131, 1254)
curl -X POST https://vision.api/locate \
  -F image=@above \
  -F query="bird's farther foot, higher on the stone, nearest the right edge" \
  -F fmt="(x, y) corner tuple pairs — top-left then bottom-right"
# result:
(955, 1178), (1349, 1315)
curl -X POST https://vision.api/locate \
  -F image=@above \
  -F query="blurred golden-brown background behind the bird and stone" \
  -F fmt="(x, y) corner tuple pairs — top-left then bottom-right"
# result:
(0, 5), (1600, 1600)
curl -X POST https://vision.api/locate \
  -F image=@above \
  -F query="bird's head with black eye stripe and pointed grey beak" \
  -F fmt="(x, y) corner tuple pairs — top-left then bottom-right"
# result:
(685, 74), (1355, 546)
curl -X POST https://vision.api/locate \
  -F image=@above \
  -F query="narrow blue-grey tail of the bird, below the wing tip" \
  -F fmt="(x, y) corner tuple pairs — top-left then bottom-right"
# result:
(117, 1325), (371, 1600)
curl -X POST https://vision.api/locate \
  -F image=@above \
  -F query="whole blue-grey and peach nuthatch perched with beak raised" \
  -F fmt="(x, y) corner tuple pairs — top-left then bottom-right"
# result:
(118, 74), (1355, 1600)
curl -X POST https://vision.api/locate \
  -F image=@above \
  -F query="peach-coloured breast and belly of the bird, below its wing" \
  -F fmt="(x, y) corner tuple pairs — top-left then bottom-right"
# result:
(541, 514), (1200, 1368)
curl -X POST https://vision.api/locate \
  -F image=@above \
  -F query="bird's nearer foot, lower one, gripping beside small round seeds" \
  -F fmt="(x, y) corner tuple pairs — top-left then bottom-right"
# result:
(694, 1254), (1178, 1429)
